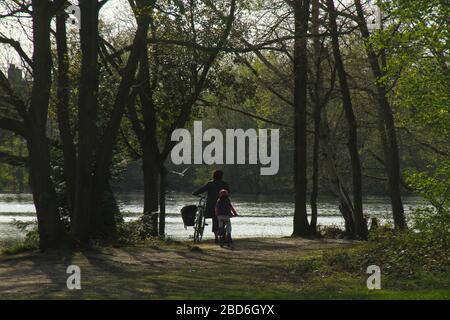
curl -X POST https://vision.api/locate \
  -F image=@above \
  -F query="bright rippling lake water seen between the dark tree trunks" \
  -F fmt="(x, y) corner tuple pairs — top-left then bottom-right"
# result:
(0, 192), (424, 240)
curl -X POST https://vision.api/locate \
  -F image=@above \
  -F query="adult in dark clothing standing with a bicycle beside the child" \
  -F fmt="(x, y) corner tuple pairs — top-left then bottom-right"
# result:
(192, 170), (230, 243)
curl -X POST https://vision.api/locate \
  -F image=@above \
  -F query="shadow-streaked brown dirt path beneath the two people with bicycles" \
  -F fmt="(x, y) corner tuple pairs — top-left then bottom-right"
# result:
(0, 238), (355, 299)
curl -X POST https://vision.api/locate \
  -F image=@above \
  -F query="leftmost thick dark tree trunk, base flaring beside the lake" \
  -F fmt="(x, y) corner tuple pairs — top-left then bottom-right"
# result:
(25, 0), (62, 249)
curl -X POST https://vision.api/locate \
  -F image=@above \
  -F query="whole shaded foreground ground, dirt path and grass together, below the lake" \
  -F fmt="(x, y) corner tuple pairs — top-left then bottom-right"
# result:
(0, 238), (450, 299)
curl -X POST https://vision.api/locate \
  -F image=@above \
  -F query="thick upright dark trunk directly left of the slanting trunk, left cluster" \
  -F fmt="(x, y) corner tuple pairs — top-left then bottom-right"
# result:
(72, 0), (99, 245)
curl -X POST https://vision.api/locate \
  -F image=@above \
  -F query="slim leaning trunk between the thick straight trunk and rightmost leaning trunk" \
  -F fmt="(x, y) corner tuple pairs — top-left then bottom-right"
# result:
(327, 0), (367, 240)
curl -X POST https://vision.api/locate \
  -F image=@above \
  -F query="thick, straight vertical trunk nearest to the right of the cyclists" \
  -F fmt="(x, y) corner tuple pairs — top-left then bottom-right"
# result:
(292, 0), (310, 236)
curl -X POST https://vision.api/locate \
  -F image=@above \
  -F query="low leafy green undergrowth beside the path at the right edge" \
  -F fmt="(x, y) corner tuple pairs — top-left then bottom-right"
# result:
(322, 208), (450, 277)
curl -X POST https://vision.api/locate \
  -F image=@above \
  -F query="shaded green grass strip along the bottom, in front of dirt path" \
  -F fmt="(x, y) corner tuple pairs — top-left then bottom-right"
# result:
(45, 252), (450, 300)
